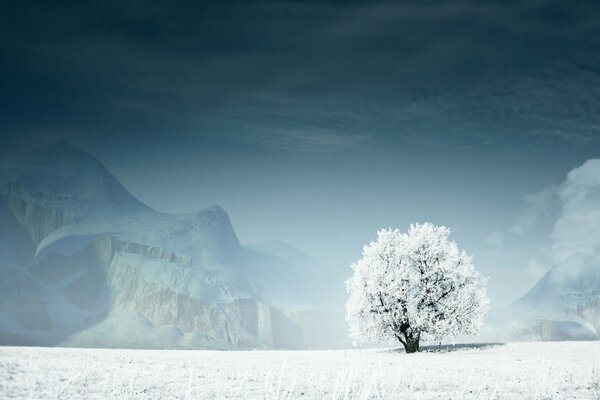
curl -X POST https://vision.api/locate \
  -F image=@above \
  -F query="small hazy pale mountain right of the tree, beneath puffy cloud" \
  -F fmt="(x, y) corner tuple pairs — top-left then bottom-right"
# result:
(490, 253), (600, 340)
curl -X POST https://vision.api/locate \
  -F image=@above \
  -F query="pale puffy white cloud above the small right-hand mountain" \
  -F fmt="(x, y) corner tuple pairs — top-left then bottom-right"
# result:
(551, 159), (600, 261)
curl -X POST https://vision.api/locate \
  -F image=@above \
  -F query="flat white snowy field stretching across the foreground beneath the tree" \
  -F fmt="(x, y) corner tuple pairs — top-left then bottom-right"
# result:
(0, 342), (600, 399)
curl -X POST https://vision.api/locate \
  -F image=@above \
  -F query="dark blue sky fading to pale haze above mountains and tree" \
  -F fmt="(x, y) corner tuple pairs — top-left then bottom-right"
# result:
(0, 0), (600, 303)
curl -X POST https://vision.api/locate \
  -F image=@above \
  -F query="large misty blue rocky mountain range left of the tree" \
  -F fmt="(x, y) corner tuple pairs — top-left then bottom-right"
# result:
(0, 141), (344, 348)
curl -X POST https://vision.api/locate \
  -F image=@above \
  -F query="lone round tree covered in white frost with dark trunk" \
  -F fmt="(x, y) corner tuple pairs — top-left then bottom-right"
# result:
(346, 223), (489, 353)
